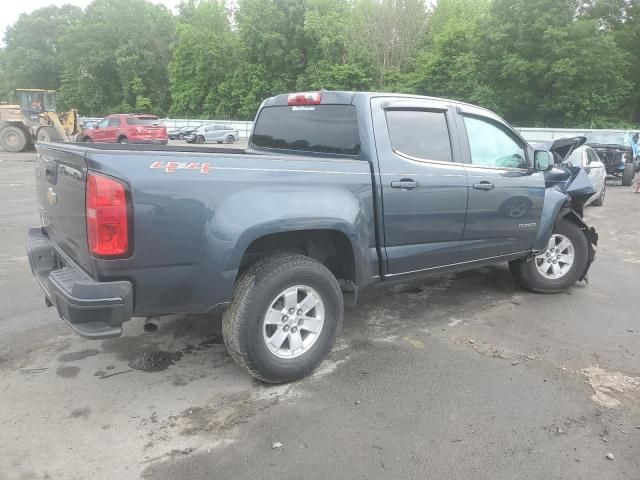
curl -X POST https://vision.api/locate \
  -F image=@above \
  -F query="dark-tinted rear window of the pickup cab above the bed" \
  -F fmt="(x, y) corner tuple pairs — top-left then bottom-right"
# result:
(252, 105), (360, 155)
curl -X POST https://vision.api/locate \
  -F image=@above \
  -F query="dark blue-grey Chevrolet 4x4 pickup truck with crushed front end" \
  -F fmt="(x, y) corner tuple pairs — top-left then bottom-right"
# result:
(27, 91), (597, 383)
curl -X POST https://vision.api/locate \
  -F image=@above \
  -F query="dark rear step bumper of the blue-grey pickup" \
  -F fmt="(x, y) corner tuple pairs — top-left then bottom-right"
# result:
(27, 227), (133, 339)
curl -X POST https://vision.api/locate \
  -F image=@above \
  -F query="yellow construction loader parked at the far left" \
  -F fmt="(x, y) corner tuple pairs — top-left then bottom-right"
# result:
(0, 88), (81, 152)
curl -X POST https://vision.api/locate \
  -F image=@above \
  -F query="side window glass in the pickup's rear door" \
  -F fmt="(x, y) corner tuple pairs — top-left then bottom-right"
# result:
(386, 110), (452, 162)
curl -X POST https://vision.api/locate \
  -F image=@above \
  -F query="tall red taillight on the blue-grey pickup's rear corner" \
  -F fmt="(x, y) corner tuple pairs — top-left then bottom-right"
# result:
(86, 172), (131, 258)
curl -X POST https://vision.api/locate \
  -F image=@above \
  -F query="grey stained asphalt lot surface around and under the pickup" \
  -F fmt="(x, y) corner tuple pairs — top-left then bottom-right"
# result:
(0, 148), (640, 480)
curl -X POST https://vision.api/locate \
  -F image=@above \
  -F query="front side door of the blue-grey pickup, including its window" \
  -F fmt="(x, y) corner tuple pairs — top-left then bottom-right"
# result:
(458, 111), (545, 262)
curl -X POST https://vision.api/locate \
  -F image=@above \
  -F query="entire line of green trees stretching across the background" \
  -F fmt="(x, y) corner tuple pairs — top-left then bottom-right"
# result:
(0, 0), (640, 128)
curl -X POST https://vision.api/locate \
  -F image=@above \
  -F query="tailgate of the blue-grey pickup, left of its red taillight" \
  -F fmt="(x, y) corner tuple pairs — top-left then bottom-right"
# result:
(35, 144), (92, 273)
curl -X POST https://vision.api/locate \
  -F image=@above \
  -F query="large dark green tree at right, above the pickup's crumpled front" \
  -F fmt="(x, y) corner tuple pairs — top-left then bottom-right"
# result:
(478, 0), (629, 126)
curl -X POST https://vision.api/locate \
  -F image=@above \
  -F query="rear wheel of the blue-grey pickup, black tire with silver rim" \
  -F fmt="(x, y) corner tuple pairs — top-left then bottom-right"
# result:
(222, 253), (344, 383)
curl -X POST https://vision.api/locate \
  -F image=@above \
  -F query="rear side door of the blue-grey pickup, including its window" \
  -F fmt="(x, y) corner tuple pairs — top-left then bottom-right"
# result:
(371, 97), (467, 276)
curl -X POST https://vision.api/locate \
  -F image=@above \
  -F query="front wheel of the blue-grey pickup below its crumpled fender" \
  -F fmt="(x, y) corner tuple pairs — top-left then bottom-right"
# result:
(509, 218), (589, 293)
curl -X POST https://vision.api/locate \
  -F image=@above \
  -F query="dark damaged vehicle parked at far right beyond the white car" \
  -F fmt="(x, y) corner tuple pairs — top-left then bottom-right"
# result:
(586, 132), (638, 187)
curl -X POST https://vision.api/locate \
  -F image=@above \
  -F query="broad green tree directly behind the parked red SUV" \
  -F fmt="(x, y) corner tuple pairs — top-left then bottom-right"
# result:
(61, 0), (175, 115)
